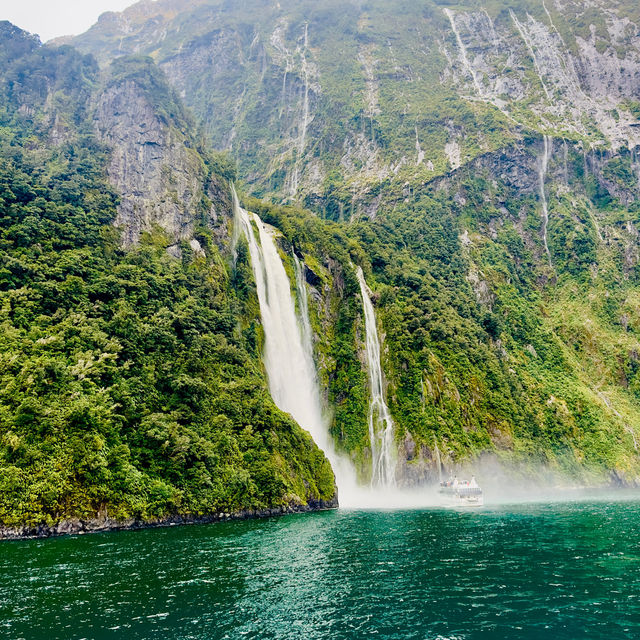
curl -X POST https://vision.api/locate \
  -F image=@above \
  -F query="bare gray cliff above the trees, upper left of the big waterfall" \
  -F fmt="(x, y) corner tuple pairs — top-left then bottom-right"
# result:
(95, 80), (217, 246)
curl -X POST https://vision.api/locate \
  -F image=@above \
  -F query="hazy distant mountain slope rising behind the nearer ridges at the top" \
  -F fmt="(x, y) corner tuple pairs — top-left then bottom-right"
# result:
(67, 0), (640, 214)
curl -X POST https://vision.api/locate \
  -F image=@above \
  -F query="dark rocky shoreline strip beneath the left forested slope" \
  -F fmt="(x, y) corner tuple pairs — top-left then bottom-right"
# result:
(0, 496), (338, 541)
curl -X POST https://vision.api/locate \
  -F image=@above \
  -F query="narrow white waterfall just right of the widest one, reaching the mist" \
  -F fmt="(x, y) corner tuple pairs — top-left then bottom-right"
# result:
(357, 267), (395, 487)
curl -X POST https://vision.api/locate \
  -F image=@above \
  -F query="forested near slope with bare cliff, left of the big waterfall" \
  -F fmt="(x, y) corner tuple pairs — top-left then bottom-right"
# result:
(0, 23), (335, 537)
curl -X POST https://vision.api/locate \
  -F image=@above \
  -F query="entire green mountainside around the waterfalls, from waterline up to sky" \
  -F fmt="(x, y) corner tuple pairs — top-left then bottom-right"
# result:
(0, 0), (640, 536)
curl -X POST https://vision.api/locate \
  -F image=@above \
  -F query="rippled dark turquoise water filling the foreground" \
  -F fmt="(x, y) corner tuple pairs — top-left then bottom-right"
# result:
(0, 500), (640, 640)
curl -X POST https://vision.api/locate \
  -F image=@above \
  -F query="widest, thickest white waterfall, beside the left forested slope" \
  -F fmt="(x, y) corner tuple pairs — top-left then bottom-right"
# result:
(234, 192), (357, 506)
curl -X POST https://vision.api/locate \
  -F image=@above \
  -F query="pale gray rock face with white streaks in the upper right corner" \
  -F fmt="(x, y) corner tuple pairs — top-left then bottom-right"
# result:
(444, 0), (640, 150)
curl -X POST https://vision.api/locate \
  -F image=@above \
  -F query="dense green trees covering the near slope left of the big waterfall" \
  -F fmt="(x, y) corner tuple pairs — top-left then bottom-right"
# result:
(0, 31), (334, 525)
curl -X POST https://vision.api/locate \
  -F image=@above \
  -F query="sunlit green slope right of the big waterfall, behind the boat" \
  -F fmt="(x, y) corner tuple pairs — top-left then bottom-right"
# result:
(241, 138), (640, 484)
